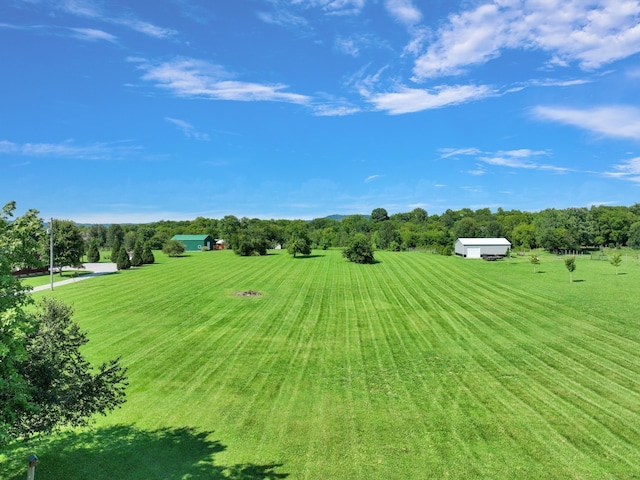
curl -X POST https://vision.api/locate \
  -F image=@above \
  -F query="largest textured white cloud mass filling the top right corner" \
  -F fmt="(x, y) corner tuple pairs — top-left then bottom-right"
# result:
(414, 0), (640, 80)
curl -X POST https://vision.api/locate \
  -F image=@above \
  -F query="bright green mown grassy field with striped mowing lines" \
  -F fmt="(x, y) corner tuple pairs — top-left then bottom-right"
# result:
(0, 250), (640, 480)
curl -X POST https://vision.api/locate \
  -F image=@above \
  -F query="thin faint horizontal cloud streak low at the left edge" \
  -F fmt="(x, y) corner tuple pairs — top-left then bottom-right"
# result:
(0, 140), (141, 160)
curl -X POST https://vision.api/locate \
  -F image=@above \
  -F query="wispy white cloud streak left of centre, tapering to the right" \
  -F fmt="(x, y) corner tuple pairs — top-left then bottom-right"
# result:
(136, 58), (311, 105)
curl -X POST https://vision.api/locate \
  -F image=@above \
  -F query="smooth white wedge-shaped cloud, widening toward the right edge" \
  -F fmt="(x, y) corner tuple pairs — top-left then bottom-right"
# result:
(533, 106), (640, 140)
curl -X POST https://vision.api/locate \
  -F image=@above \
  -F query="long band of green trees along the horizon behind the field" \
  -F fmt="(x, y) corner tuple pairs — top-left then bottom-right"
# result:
(79, 204), (640, 258)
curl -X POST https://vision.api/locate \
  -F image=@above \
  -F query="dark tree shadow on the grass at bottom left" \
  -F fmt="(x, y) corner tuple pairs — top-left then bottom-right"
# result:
(0, 425), (288, 480)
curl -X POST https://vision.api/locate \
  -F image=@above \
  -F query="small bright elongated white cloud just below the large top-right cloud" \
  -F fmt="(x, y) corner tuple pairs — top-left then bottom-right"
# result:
(368, 85), (495, 115)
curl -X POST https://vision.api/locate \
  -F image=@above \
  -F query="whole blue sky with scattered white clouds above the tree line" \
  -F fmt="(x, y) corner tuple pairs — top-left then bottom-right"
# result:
(0, 0), (640, 223)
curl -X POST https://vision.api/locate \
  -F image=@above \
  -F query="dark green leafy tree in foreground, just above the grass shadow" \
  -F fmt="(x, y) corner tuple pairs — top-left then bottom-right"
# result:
(18, 298), (127, 436)
